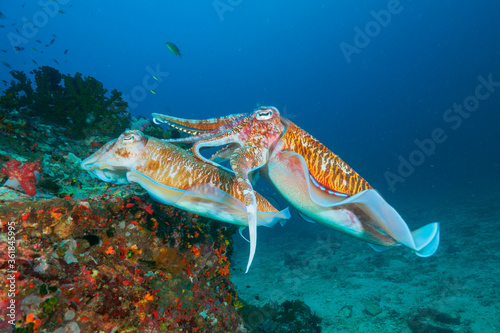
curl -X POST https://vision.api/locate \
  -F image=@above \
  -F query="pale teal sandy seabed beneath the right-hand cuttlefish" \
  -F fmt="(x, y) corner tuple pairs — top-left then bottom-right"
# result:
(232, 191), (500, 333)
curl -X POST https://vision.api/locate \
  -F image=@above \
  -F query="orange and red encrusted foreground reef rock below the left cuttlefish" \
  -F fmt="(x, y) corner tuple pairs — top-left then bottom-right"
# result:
(0, 188), (248, 332)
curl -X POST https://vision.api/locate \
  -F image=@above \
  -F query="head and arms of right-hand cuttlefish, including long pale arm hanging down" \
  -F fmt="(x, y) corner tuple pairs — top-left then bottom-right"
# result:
(153, 108), (284, 272)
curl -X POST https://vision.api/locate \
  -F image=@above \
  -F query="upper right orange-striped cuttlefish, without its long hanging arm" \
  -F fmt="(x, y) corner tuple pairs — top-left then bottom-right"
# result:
(153, 107), (440, 257)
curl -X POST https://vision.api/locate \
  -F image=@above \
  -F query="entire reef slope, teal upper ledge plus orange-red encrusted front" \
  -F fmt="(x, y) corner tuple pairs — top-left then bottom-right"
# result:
(0, 109), (246, 332)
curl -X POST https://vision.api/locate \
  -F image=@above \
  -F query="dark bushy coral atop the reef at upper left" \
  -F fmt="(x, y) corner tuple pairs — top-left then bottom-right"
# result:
(0, 66), (130, 139)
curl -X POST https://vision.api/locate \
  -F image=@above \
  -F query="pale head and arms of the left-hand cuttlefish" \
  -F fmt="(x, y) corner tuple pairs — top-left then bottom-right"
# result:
(80, 131), (148, 184)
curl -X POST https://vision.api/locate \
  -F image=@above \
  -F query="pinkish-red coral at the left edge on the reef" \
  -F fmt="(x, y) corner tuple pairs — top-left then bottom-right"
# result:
(0, 159), (42, 196)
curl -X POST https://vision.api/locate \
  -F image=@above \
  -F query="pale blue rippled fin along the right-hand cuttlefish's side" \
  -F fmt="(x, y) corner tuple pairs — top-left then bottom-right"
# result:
(282, 151), (439, 257)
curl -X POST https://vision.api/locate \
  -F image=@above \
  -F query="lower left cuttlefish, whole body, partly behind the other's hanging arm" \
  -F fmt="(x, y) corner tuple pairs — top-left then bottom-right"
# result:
(81, 130), (290, 256)
